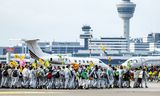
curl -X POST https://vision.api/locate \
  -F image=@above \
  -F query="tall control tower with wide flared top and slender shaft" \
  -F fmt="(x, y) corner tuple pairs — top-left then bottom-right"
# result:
(117, 0), (136, 51)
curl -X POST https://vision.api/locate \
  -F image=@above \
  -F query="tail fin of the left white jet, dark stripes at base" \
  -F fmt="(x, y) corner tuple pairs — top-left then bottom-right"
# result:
(23, 39), (44, 60)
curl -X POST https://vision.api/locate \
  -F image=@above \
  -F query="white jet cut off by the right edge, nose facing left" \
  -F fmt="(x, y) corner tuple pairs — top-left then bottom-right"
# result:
(122, 56), (160, 68)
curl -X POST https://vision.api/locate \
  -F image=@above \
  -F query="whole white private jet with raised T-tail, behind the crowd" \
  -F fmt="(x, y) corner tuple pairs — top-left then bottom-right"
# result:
(23, 39), (108, 68)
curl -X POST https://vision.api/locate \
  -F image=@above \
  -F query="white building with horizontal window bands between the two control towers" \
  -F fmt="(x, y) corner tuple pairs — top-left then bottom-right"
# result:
(89, 37), (127, 54)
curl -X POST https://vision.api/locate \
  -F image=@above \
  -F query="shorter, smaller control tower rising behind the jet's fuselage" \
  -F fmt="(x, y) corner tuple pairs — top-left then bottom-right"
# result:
(80, 25), (92, 50)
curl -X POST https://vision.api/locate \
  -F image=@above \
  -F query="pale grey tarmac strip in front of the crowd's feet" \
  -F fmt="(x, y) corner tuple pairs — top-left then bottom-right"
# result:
(0, 82), (160, 96)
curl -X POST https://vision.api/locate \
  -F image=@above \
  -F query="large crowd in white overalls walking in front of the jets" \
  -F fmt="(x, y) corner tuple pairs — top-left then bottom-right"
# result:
(0, 64), (160, 89)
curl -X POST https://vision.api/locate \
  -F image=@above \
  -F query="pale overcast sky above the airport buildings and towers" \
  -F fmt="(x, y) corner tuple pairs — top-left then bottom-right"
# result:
(0, 0), (160, 46)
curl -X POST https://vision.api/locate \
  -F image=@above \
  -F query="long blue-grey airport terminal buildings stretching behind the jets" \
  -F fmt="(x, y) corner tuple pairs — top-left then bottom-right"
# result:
(0, 33), (160, 63)
